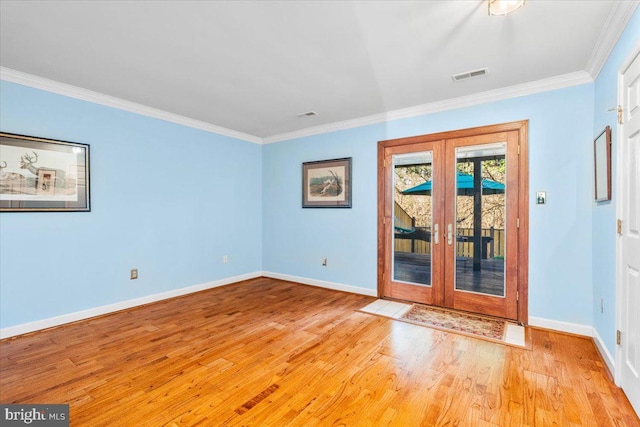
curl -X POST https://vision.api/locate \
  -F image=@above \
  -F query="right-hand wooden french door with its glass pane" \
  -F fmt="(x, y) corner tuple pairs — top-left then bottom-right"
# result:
(444, 132), (519, 319)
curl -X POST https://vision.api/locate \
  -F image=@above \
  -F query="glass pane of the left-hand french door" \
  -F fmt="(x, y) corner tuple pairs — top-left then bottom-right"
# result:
(391, 151), (433, 286)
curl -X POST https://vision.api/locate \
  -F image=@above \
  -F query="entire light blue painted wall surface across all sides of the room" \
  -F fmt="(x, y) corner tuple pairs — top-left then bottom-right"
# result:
(0, 12), (640, 334)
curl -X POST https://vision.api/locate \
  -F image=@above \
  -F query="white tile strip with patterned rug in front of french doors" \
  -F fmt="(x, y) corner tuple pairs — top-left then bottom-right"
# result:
(360, 300), (528, 348)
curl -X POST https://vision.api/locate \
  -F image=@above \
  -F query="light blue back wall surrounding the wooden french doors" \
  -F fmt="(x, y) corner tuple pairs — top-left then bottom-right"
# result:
(263, 84), (593, 325)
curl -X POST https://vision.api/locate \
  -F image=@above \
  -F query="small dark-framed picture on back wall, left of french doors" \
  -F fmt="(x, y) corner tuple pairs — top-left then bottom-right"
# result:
(302, 157), (351, 208)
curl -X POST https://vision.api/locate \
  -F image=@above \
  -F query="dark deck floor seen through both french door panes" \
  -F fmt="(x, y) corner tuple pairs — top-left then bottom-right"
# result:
(393, 252), (504, 295)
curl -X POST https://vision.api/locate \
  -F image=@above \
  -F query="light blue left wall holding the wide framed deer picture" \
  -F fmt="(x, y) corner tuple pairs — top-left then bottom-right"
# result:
(0, 82), (262, 328)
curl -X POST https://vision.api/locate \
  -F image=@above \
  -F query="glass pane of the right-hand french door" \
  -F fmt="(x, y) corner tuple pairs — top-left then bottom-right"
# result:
(455, 143), (507, 296)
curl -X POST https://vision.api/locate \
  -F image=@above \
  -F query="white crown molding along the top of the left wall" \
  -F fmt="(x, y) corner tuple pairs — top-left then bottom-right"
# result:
(0, 67), (262, 144)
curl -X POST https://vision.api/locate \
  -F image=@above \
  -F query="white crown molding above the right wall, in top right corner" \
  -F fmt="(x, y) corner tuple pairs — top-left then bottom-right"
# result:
(586, 0), (640, 80)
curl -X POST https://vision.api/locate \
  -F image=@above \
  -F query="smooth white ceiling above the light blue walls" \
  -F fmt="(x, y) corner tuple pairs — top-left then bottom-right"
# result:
(0, 0), (638, 141)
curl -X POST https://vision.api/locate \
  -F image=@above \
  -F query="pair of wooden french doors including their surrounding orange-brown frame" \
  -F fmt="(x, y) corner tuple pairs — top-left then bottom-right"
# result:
(378, 122), (528, 323)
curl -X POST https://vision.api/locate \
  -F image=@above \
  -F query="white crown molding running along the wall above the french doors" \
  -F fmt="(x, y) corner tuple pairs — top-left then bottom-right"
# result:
(263, 71), (593, 144)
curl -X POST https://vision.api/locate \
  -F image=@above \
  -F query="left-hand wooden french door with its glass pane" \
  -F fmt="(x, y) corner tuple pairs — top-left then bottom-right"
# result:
(380, 142), (444, 305)
